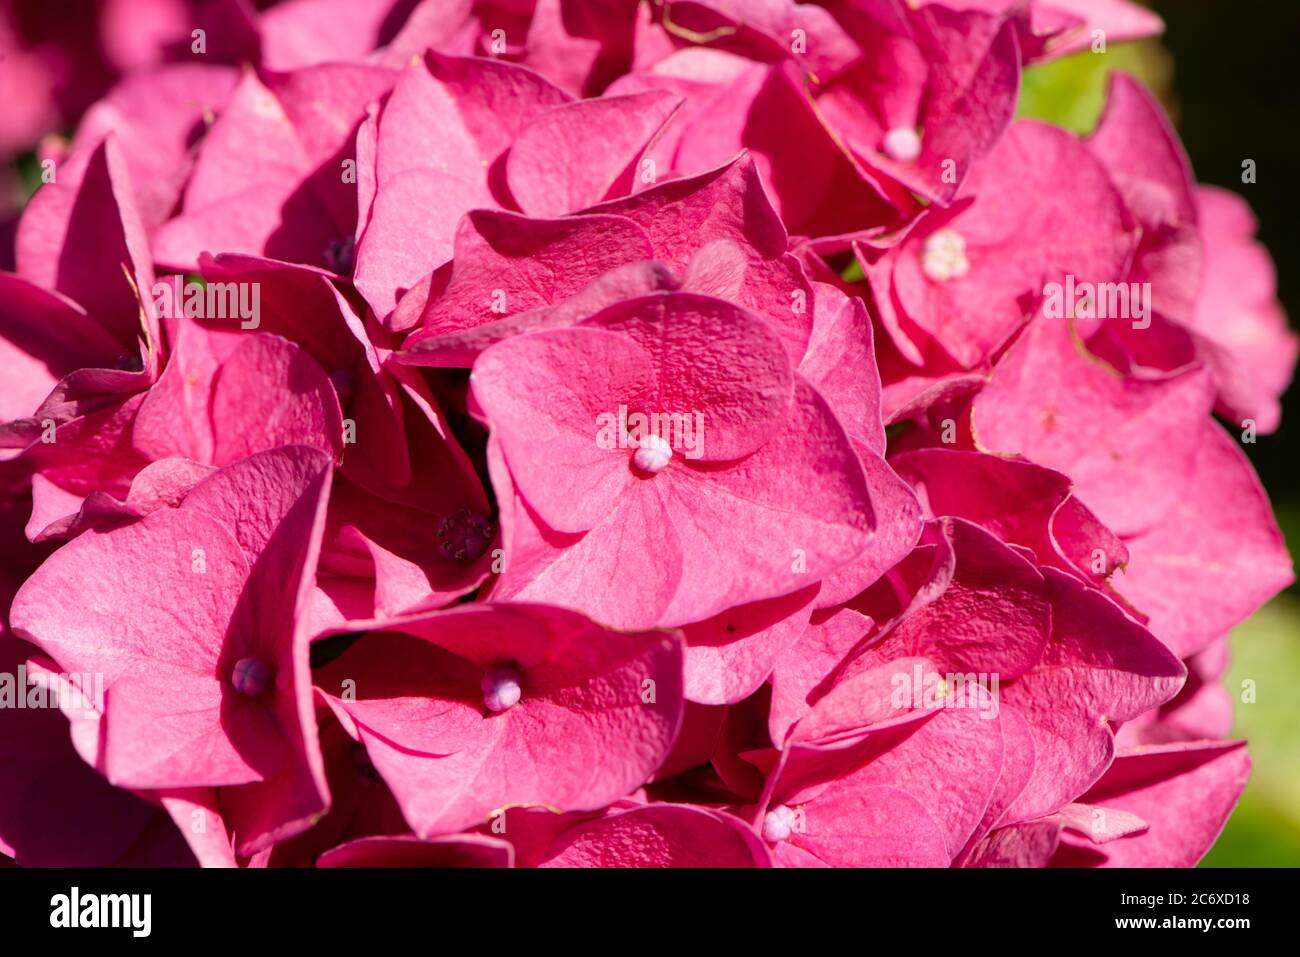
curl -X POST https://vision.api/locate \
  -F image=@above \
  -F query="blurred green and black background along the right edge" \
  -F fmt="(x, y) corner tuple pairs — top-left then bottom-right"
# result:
(1021, 0), (1300, 867)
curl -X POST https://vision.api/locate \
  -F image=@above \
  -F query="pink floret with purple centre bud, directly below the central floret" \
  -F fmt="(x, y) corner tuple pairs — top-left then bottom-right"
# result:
(317, 605), (684, 835)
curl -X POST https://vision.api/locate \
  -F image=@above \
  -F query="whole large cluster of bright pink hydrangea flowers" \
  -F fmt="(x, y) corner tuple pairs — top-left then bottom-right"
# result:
(0, 0), (1296, 867)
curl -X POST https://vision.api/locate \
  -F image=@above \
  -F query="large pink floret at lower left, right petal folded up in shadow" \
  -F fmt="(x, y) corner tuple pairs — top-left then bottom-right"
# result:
(12, 449), (328, 816)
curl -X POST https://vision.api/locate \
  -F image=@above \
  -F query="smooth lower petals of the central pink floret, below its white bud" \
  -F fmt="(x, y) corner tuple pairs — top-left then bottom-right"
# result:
(485, 369), (874, 628)
